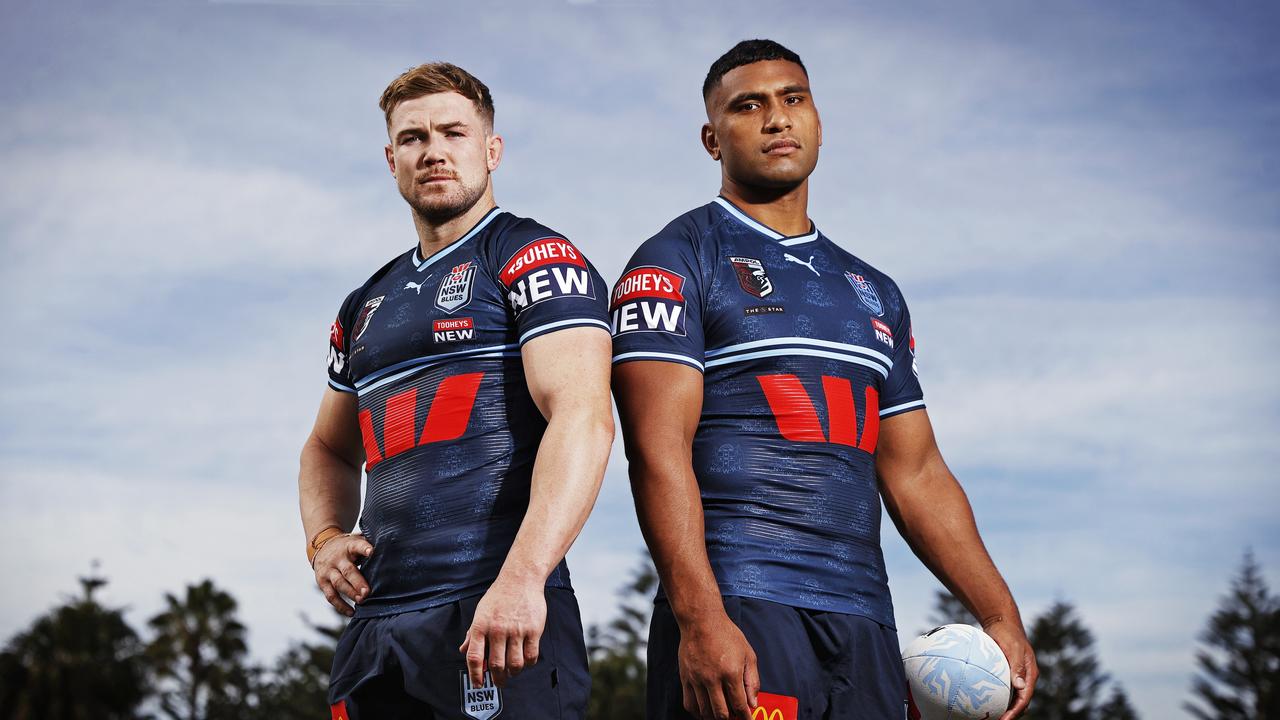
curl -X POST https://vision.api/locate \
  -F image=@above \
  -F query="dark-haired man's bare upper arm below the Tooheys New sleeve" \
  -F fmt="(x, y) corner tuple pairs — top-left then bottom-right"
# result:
(613, 360), (703, 462)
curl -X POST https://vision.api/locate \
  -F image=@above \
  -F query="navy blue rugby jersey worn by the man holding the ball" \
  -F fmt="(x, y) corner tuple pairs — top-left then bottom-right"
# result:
(611, 197), (924, 625)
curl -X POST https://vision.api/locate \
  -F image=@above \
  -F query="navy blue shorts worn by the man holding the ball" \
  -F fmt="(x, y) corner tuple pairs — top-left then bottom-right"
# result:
(648, 597), (906, 720)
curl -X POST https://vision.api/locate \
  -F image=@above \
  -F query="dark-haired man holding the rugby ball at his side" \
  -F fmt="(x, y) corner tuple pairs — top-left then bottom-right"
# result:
(611, 40), (1037, 720)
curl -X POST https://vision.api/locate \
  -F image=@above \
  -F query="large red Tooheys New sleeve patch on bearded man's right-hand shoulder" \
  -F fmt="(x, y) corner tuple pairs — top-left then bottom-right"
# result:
(498, 237), (595, 315)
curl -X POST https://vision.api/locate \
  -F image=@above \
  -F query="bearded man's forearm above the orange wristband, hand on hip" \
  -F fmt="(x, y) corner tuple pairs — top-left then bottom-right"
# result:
(298, 436), (360, 538)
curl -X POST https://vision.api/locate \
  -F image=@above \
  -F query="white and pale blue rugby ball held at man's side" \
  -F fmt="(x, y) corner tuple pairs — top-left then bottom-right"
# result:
(902, 625), (1011, 720)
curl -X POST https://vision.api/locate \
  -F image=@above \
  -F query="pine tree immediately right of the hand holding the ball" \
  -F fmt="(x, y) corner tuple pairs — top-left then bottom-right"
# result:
(1024, 601), (1107, 720)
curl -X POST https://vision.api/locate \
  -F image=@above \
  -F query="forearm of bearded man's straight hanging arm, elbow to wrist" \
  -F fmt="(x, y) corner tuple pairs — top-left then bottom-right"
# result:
(499, 400), (613, 584)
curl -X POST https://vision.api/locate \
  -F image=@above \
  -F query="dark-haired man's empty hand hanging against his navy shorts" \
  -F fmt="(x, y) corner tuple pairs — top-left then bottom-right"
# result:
(680, 612), (760, 720)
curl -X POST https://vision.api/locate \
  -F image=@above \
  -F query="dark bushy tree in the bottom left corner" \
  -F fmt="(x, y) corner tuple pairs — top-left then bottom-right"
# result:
(0, 568), (147, 720)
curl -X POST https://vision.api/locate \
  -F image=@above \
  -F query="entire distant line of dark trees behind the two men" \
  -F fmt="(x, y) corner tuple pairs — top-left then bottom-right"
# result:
(0, 552), (1280, 720)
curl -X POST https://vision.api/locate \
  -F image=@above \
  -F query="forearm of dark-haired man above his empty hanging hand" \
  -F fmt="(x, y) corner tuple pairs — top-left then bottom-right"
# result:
(630, 452), (724, 628)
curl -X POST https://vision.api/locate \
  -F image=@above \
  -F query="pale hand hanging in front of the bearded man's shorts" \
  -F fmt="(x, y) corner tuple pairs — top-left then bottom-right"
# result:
(458, 577), (547, 688)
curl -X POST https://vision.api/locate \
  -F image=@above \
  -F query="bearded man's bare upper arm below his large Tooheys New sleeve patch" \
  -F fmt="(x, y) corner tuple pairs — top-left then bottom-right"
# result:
(520, 327), (612, 419)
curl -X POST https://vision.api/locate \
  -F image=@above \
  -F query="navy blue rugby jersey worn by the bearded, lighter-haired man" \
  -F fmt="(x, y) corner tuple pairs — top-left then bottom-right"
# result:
(329, 208), (608, 618)
